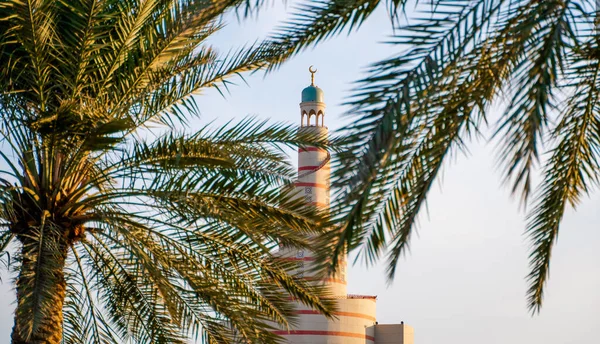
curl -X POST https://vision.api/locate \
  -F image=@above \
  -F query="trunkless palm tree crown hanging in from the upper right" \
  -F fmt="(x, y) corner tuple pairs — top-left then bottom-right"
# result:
(271, 0), (600, 313)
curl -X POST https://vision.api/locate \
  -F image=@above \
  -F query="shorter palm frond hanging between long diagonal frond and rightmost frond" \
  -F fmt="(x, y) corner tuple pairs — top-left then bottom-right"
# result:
(495, 1), (575, 204)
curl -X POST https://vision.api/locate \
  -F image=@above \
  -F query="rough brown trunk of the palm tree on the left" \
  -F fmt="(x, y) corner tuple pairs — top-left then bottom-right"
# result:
(12, 233), (67, 344)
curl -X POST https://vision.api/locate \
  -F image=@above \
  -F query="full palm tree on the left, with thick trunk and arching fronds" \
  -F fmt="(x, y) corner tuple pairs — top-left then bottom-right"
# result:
(0, 0), (331, 344)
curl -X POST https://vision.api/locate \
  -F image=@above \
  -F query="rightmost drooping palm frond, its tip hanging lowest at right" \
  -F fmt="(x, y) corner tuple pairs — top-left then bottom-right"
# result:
(527, 39), (600, 312)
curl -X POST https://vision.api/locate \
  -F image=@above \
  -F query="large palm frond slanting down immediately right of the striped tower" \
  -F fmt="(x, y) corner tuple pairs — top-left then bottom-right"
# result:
(326, 1), (519, 278)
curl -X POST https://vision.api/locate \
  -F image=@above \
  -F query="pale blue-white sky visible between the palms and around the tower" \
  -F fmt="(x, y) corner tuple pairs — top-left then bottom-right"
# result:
(0, 2), (600, 344)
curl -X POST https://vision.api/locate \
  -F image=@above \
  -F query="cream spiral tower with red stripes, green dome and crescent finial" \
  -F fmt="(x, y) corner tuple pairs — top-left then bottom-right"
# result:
(276, 67), (376, 344)
